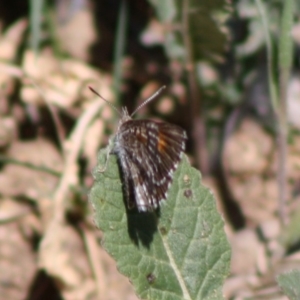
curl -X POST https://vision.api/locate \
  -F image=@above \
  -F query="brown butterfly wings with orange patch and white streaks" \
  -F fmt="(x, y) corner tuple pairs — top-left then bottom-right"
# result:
(114, 120), (187, 211)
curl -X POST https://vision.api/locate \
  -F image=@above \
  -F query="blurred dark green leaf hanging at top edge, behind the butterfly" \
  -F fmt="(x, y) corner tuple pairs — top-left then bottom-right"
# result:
(148, 0), (232, 61)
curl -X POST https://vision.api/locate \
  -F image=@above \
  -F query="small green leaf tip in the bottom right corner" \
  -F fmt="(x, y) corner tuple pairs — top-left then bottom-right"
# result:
(277, 270), (300, 300)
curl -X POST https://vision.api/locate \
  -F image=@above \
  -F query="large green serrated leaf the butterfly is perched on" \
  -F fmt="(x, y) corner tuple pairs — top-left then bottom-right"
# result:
(90, 149), (230, 300)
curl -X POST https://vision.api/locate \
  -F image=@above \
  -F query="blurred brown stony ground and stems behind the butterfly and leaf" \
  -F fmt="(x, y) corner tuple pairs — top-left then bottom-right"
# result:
(0, 0), (300, 300)
